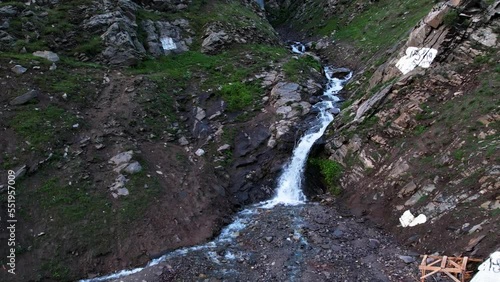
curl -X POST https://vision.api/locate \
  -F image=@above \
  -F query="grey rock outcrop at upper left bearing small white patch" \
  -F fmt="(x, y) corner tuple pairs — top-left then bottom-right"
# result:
(82, 0), (192, 65)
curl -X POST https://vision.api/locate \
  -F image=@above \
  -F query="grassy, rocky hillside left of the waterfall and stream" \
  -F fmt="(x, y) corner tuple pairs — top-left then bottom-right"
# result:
(0, 0), (328, 281)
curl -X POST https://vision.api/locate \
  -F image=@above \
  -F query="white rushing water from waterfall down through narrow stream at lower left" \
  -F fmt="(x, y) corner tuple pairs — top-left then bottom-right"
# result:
(81, 42), (352, 282)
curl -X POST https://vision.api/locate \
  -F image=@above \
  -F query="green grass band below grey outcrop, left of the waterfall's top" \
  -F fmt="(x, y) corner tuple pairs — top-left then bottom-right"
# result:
(131, 45), (287, 111)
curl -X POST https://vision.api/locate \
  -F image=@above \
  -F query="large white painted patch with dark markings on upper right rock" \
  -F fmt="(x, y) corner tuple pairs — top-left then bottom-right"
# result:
(396, 47), (437, 74)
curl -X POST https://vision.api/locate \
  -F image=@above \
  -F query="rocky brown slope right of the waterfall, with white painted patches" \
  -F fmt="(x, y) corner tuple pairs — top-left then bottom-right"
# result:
(296, 1), (500, 256)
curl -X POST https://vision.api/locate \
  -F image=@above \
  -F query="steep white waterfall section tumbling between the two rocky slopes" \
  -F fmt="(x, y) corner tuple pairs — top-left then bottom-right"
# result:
(264, 67), (352, 208)
